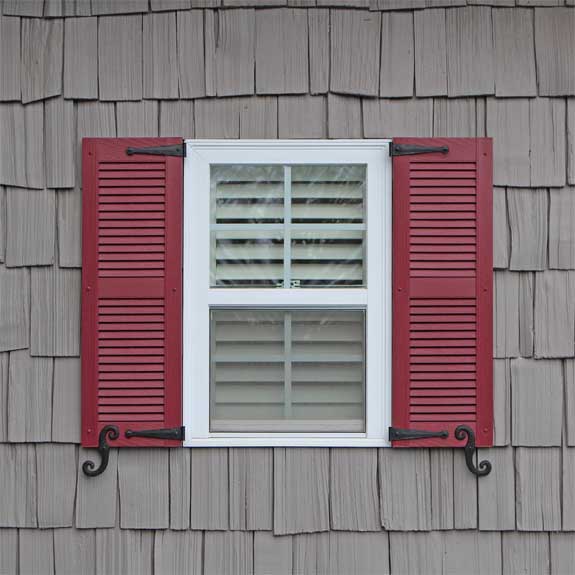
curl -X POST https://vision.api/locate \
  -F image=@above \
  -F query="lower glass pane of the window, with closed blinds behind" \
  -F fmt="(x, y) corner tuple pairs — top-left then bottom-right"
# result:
(210, 309), (365, 432)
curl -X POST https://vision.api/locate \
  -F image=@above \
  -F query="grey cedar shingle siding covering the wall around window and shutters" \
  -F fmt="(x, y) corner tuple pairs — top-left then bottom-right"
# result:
(0, 0), (575, 575)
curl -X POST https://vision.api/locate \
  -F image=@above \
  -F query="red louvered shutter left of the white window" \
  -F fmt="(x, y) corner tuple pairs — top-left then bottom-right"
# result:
(82, 138), (183, 447)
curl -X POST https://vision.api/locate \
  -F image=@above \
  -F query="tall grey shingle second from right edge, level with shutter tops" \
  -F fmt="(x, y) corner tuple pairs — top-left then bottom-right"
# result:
(529, 99), (575, 187)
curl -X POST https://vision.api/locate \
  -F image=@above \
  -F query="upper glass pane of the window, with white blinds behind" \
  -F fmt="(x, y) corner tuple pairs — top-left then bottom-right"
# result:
(211, 164), (366, 288)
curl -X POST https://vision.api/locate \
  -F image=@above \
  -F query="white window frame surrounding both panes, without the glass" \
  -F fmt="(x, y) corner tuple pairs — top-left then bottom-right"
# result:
(182, 140), (392, 447)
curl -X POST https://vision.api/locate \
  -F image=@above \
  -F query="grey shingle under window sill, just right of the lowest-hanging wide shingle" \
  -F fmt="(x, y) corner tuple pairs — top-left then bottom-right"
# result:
(329, 448), (381, 531)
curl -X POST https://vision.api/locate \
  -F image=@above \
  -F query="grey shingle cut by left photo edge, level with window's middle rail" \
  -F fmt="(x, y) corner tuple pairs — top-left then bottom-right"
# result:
(0, 267), (30, 351)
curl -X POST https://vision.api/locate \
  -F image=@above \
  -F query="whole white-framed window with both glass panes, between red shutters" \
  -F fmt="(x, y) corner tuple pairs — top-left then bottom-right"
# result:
(183, 141), (391, 445)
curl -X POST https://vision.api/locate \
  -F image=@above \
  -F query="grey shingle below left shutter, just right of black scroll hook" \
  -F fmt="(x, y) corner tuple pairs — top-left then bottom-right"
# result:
(118, 448), (170, 529)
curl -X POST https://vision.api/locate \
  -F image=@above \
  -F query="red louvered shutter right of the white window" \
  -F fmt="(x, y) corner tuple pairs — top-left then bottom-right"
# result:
(392, 138), (493, 447)
